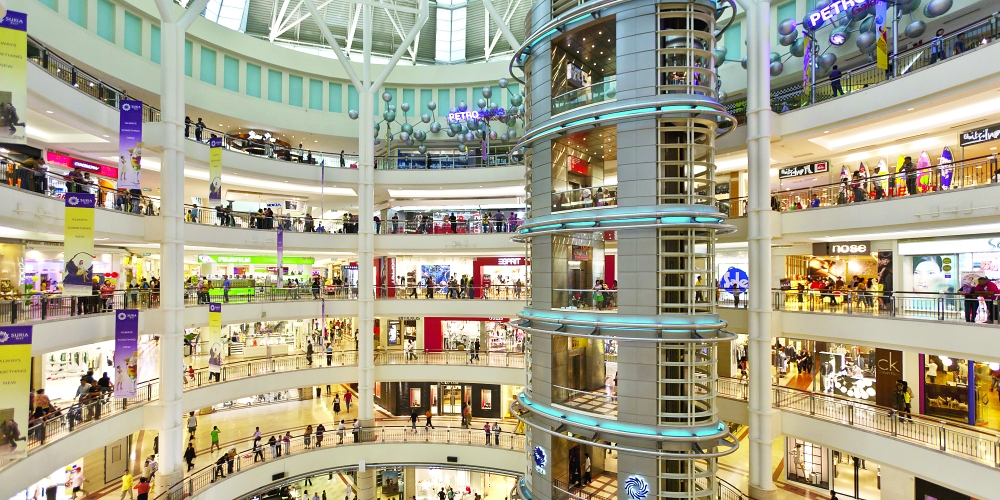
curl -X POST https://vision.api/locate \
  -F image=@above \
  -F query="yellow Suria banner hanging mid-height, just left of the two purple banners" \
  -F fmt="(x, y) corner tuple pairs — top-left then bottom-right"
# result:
(63, 193), (97, 296)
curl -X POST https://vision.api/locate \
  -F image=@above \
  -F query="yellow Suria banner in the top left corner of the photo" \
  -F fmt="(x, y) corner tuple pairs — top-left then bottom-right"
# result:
(0, 10), (28, 144)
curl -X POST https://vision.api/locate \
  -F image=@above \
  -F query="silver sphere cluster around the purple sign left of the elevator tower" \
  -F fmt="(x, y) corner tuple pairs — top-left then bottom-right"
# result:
(347, 78), (524, 153)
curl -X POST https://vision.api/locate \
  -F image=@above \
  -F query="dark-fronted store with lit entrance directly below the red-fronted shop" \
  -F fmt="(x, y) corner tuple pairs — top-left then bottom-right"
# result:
(375, 382), (522, 419)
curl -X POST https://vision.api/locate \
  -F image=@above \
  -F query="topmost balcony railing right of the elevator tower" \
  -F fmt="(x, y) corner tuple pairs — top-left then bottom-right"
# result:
(726, 13), (1000, 124)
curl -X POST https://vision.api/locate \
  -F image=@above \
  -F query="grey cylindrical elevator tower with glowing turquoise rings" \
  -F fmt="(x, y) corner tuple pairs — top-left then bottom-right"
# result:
(512, 0), (737, 500)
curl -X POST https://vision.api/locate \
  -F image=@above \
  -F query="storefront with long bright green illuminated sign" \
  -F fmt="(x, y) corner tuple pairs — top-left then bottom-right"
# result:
(198, 255), (316, 285)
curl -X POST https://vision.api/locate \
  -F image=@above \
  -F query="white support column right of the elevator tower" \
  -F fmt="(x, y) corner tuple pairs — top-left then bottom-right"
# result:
(744, 0), (777, 500)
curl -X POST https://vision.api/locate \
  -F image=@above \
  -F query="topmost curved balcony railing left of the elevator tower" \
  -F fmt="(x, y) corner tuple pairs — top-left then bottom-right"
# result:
(28, 37), (524, 170)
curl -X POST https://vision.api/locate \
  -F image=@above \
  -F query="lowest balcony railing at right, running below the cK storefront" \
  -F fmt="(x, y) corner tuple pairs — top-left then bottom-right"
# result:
(718, 379), (1000, 468)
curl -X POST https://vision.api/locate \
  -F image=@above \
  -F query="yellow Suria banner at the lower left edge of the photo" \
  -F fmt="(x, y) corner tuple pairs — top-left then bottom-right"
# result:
(0, 325), (31, 460)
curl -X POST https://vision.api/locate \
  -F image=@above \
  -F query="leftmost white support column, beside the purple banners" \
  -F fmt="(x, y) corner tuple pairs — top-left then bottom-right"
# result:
(150, 0), (208, 491)
